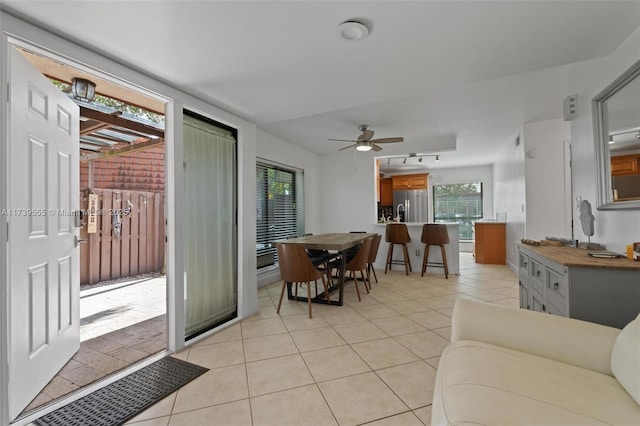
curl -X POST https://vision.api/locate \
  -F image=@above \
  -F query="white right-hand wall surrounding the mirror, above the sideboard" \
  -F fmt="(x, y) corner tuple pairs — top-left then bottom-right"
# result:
(568, 28), (640, 253)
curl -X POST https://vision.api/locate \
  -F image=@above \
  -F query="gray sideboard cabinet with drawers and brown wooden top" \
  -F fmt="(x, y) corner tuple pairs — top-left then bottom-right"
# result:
(518, 244), (640, 328)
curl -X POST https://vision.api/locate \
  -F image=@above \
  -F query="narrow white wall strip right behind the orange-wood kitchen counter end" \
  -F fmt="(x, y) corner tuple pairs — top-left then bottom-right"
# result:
(493, 131), (526, 271)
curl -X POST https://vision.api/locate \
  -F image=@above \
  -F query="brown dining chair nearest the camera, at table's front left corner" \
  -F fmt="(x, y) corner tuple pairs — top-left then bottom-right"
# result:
(277, 243), (331, 318)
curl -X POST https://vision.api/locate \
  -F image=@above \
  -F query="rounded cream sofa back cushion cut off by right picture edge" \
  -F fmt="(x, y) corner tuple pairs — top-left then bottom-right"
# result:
(611, 315), (640, 406)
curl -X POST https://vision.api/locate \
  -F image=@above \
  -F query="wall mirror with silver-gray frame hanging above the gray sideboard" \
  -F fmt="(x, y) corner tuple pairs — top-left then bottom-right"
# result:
(592, 61), (640, 210)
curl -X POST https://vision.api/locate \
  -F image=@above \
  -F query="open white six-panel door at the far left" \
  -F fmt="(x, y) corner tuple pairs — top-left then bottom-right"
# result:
(8, 48), (80, 419)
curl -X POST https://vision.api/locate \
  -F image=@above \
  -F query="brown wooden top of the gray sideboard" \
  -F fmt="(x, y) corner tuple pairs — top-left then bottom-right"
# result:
(518, 243), (640, 271)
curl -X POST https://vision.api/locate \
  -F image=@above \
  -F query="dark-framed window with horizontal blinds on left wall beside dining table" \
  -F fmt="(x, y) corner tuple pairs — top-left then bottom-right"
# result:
(256, 160), (304, 269)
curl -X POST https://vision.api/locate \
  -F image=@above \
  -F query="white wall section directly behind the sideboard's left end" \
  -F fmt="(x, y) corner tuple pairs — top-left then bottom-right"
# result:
(523, 119), (572, 240)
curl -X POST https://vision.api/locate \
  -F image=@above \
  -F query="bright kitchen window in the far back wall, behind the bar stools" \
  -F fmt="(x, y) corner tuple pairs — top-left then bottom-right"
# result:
(433, 182), (483, 241)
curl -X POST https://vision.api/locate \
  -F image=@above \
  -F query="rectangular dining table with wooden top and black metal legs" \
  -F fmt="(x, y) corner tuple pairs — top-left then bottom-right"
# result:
(275, 232), (376, 306)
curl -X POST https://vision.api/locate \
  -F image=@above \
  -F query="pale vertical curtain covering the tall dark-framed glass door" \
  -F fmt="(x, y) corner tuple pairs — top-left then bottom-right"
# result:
(184, 115), (237, 337)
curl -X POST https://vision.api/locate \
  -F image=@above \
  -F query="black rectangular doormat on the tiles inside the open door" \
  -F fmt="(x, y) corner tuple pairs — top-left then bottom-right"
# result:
(35, 357), (208, 426)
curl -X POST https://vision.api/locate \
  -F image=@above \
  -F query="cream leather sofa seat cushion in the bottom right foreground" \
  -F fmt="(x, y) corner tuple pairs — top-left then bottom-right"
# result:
(432, 340), (640, 425)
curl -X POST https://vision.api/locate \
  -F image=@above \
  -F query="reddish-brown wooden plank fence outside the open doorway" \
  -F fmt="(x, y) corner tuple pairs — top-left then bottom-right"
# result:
(80, 189), (165, 285)
